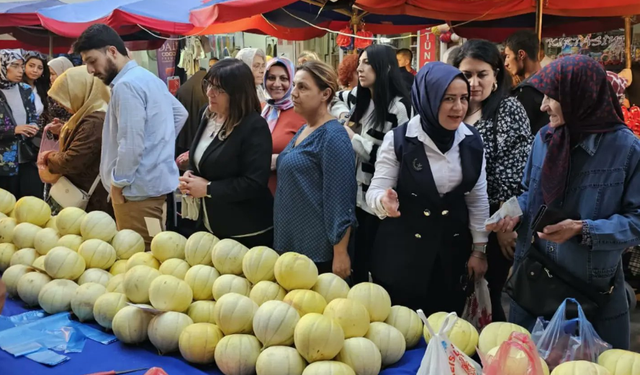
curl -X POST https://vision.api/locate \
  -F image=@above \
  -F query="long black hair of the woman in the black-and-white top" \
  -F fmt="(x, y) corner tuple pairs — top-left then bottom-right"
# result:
(353, 44), (409, 130)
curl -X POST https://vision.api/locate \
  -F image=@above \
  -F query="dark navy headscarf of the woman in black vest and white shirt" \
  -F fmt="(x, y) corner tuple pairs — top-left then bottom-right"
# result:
(411, 62), (469, 154)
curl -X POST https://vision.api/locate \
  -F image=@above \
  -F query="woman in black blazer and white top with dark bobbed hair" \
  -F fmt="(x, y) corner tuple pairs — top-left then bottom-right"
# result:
(180, 59), (273, 248)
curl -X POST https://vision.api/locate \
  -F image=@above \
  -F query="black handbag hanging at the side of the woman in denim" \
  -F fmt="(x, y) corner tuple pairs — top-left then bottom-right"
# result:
(505, 244), (620, 320)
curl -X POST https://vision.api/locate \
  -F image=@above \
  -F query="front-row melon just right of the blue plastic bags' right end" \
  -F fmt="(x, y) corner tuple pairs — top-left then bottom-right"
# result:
(111, 306), (153, 345)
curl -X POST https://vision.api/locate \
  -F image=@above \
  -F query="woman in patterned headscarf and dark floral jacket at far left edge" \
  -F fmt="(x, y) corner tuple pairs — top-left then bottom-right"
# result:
(0, 50), (37, 198)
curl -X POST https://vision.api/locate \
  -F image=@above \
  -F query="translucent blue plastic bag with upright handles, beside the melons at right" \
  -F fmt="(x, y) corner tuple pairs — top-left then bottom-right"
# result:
(531, 298), (611, 370)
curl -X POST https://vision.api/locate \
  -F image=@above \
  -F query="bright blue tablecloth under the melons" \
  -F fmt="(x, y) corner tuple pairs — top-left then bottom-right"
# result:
(0, 299), (426, 375)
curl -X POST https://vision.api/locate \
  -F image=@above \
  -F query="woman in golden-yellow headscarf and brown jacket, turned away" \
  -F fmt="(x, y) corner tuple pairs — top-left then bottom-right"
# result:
(38, 66), (113, 213)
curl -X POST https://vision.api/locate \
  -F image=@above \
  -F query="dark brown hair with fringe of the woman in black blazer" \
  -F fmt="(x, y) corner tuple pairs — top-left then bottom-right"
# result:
(202, 59), (262, 137)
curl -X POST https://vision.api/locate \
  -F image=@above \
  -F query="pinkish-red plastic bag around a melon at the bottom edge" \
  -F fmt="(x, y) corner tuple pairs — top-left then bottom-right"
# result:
(482, 332), (544, 375)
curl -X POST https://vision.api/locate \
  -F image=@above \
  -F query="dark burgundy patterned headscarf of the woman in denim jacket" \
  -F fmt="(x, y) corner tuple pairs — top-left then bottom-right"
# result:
(530, 55), (624, 204)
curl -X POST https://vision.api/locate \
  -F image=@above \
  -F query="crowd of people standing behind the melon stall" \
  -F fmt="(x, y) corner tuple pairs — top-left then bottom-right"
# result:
(0, 25), (640, 349)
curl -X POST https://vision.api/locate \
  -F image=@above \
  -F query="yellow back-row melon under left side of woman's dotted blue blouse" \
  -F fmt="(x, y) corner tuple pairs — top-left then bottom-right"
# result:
(273, 253), (318, 291)
